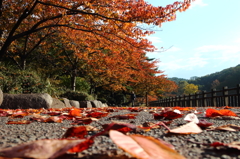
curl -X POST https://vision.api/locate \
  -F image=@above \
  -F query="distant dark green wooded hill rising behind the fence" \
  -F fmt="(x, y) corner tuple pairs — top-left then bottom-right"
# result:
(169, 64), (240, 91)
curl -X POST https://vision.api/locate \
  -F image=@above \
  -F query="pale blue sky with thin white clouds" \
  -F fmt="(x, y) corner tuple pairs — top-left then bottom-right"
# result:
(146, 0), (240, 79)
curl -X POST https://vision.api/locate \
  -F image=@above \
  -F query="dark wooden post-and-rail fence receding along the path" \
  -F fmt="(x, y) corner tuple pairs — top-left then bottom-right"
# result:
(149, 84), (240, 107)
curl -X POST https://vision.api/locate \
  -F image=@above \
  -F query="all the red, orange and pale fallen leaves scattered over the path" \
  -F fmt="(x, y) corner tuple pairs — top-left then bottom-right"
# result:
(0, 107), (240, 159)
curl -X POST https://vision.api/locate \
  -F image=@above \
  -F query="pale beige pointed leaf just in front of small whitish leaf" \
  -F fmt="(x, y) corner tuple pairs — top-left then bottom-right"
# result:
(168, 122), (202, 134)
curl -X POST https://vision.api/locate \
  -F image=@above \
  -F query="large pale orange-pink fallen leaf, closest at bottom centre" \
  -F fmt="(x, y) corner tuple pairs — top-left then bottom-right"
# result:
(109, 130), (185, 159)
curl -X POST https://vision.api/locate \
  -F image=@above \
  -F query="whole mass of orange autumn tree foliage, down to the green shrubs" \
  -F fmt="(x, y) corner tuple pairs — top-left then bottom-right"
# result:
(0, 0), (195, 98)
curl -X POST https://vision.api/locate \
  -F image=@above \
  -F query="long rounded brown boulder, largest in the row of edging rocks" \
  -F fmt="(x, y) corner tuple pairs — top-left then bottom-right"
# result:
(0, 93), (53, 109)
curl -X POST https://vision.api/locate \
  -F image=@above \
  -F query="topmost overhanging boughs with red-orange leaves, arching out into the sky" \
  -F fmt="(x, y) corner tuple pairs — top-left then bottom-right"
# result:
(0, 0), (191, 58)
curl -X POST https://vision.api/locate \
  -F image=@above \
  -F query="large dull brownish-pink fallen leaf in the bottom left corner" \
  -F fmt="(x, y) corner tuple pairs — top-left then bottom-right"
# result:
(0, 139), (85, 158)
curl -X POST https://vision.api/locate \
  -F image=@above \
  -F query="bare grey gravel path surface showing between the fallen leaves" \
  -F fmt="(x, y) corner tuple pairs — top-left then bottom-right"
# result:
(0, 109), (240, 159)
